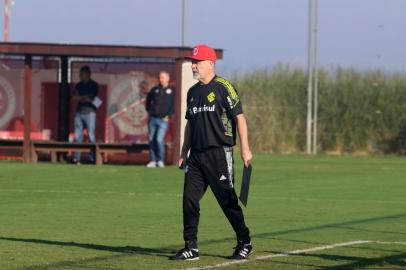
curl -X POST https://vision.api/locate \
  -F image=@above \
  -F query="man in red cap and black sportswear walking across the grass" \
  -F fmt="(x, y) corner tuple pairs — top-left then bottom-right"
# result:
(170, 45), (252, 260)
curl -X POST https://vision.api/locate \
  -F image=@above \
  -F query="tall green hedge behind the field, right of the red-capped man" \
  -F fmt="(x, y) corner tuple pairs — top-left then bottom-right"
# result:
(232, 64), (406, 153)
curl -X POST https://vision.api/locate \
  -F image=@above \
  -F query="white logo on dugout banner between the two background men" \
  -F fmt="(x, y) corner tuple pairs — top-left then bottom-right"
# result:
(109, 75), (148, 135)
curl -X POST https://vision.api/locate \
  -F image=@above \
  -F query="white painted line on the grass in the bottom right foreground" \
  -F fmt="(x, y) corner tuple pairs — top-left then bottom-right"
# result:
(185, 240), (406, 270)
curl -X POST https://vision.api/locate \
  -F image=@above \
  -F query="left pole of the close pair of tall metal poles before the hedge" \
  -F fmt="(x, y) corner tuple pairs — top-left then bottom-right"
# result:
(306, 0), (313, 154)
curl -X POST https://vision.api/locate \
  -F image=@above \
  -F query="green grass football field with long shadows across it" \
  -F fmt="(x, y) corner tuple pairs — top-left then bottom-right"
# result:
(0, 154), (406, 270)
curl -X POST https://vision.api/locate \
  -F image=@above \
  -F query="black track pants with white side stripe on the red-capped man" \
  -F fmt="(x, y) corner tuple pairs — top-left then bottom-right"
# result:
(183, 147), (250, 243)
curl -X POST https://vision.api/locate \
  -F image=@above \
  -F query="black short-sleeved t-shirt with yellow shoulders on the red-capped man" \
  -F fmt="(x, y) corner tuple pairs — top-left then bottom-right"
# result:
(185, 76), (242, 151)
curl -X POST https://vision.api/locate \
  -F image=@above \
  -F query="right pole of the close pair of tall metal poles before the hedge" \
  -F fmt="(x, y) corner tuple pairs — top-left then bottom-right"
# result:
(313, 0), (319, 155)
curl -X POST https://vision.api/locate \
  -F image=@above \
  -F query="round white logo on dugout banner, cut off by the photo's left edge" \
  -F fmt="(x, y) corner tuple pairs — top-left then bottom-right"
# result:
(0, 76), (17, 127)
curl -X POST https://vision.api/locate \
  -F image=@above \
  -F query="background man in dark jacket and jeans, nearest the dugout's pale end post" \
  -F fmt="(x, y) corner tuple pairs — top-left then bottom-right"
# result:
(146, 70), (174, 168)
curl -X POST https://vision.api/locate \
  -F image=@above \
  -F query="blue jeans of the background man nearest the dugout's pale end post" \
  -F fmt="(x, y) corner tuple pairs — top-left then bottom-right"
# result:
(148, 116), (168, 161)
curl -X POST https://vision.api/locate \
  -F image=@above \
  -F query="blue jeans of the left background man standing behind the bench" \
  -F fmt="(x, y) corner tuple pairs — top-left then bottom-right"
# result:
(73, 112), (96, 162)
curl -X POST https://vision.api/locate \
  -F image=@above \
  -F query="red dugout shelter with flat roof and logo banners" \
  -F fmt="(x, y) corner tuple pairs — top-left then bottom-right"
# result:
(0, 42), (223, 162)
